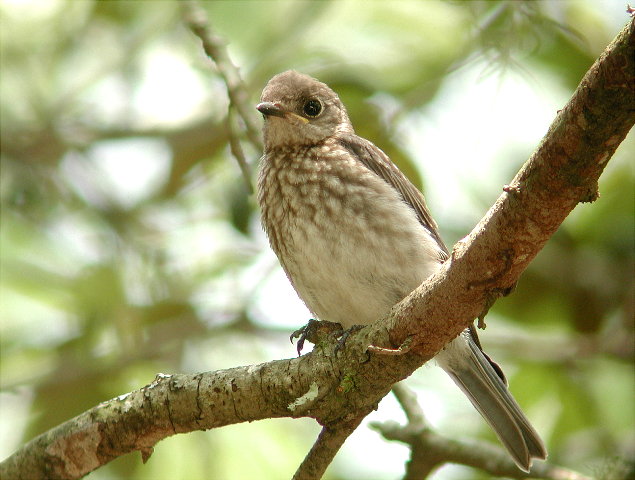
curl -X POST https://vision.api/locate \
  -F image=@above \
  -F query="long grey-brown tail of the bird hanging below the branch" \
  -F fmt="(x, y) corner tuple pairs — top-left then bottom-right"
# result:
(436, 332), (547, 472)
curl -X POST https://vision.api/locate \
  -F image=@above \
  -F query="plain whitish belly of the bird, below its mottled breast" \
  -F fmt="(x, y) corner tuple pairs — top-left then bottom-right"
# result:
(285, 169), (440, 328)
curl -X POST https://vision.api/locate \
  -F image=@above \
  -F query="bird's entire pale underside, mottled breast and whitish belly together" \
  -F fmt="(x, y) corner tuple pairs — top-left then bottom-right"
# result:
(258, 147), (439, 327)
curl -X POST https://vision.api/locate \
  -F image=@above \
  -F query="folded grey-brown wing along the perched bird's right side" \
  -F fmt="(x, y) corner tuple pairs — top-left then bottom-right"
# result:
(338, 135), (448, 260)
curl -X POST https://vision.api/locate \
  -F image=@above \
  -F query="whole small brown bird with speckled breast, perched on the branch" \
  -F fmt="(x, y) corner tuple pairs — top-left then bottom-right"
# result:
(256, 70), (547, 472)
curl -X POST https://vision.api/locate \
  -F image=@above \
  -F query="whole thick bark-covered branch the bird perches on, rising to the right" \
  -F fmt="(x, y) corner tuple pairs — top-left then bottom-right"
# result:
(0, 16), (635, 479)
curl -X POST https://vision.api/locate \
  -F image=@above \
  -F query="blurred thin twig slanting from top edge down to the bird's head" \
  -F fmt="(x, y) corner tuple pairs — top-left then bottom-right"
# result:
(181, 0), (262, 150)
